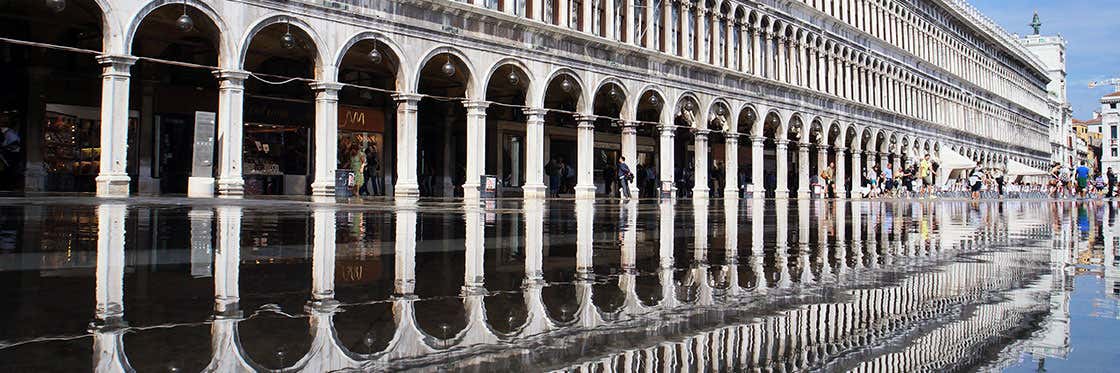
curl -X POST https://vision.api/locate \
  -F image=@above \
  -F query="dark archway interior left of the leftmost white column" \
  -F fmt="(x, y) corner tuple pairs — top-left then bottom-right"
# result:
(0, 0), (102, 192)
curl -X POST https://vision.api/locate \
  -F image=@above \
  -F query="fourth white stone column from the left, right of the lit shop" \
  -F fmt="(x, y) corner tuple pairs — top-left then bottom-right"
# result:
(393, 93), (421, 197)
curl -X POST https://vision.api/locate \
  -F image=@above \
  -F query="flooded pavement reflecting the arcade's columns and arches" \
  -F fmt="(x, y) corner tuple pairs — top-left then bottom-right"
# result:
(0, 197), (1120, 372)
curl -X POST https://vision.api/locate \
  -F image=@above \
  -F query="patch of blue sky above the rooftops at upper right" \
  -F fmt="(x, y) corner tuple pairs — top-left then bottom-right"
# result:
(969, 0), (1120, 120)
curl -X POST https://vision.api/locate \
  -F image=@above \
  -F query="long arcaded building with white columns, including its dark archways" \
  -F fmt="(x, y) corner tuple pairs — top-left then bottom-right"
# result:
(0, 0), (1064, 197)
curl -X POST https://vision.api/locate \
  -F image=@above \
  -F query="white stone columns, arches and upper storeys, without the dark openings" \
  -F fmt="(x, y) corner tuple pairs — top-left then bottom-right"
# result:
(39, 0), (1053, 197)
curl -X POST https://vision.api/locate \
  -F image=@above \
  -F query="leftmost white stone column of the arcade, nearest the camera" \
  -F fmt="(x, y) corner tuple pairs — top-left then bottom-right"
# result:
(96, 55), (137, 197)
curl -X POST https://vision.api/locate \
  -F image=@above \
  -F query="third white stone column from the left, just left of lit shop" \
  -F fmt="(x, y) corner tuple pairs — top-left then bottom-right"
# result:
(311, 82), (340, 197)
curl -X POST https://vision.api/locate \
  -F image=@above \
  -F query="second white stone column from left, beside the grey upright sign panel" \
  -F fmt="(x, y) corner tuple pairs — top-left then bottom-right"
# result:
(214, 69), (249, 197)
